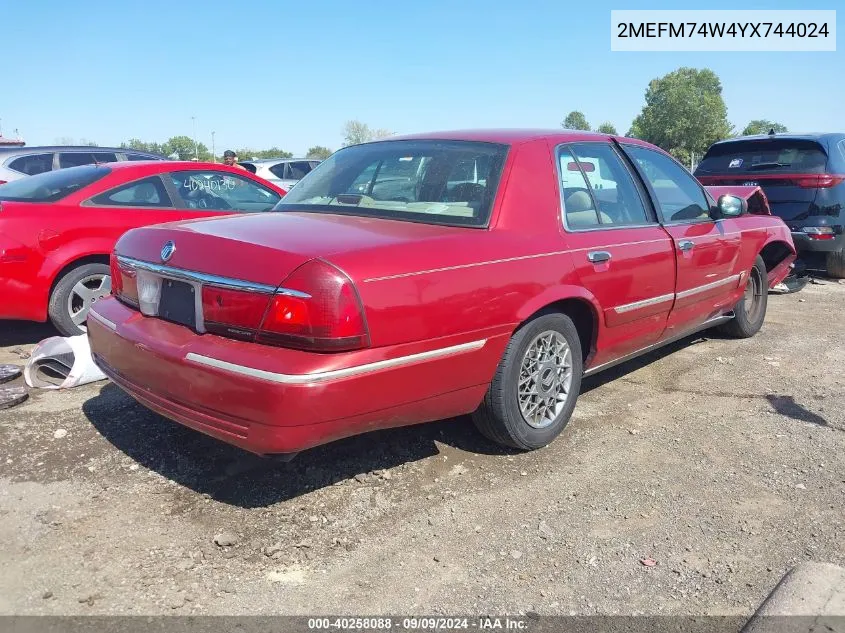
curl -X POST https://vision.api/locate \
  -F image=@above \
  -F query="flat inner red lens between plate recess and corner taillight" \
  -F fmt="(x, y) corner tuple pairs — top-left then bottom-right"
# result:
(202, 286), (271, 340)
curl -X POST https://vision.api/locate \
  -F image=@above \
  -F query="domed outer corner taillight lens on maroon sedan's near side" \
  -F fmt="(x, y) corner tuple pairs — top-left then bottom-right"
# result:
(258, 259), (369, 352)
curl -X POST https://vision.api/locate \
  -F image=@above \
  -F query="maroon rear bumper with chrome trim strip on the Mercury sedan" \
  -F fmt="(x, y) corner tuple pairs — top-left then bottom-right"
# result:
(88, 299), (507, 454)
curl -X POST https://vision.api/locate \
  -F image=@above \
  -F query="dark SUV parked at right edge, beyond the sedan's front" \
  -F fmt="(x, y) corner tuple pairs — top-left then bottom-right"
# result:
(695, 133), (845, 278)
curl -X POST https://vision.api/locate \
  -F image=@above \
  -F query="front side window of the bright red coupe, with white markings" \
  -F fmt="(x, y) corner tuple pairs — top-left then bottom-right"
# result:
(169, 170), (282, 212)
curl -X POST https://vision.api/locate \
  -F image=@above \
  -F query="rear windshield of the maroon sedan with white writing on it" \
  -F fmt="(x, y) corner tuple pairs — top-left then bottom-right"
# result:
(276, 140), (507, 226)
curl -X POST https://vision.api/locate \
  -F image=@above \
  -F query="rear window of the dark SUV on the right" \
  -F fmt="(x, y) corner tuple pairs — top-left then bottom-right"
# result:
(695, 139), (827, 174)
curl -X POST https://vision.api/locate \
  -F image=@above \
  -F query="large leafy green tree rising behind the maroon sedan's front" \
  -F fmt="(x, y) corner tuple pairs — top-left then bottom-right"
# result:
(628, 67), (732, 164)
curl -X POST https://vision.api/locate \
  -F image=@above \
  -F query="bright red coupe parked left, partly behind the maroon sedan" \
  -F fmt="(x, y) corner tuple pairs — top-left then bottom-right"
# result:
(0, 161), (285, 336)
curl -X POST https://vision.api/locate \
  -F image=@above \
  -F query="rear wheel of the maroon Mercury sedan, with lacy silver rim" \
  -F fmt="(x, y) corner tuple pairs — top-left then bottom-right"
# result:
(472, 313), (583, 450)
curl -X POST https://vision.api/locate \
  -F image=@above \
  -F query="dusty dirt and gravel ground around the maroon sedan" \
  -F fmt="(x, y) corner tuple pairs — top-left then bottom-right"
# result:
(0, 281), (845, 615)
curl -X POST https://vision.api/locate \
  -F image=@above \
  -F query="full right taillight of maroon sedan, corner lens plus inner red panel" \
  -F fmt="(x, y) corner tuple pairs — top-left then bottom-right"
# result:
(202, 259), (369, 352)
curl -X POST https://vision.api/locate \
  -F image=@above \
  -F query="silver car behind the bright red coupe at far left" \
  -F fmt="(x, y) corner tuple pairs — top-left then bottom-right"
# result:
(0, 145), (167, 184)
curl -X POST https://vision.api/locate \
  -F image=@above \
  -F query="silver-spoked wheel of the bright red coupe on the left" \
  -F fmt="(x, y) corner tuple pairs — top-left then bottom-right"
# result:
(47, 264), (111, 336)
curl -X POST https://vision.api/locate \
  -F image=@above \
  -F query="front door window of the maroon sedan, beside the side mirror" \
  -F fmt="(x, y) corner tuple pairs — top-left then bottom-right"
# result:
(625, 145), (710, 222)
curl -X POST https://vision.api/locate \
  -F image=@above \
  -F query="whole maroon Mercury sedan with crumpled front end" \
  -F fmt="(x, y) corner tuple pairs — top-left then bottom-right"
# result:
(88, 131), (795, 454)
